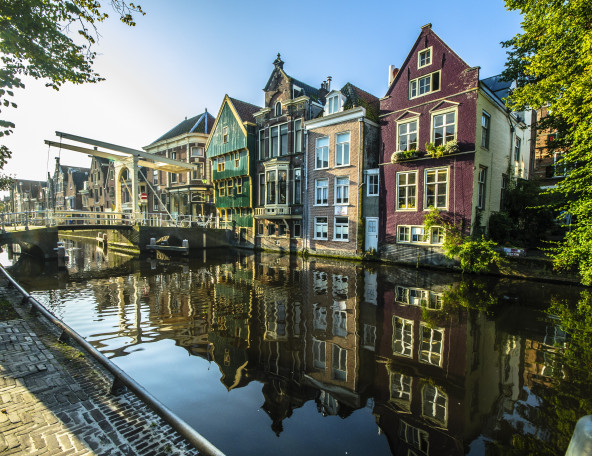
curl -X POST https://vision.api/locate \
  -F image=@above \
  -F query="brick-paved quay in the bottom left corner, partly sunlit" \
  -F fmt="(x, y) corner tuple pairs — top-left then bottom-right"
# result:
(0, 280), (198, 456)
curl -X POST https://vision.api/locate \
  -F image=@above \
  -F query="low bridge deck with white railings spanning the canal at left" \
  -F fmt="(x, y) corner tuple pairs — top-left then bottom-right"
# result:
(0, 210), (233, 259)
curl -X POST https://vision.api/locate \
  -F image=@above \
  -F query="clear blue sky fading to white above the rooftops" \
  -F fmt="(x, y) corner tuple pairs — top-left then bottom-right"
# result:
(3, 0), (520, 179)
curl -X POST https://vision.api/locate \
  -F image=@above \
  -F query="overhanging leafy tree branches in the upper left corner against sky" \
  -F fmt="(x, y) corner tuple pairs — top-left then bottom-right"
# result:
(0, 0), (145, 188)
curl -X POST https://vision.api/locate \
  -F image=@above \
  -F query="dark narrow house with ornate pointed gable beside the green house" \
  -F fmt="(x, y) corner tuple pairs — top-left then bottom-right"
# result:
(254, 54), (327, 251)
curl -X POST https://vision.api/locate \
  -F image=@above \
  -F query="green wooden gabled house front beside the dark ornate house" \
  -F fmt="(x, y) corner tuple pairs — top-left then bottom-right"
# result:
(206, 95), (261, 244)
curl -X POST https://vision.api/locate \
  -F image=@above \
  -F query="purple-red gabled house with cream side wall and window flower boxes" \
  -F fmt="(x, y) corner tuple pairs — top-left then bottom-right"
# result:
(380, 24), (531, 264)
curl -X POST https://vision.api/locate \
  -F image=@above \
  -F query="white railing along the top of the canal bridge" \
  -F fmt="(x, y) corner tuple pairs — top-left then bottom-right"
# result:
(0, 210), (222, 231)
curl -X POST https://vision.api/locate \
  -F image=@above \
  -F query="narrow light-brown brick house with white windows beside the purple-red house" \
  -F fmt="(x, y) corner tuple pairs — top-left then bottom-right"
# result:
(306, 83), (380, 256)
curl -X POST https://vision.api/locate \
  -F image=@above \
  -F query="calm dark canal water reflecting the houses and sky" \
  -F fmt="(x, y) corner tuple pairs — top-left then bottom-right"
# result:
(2, 240), (592, 456)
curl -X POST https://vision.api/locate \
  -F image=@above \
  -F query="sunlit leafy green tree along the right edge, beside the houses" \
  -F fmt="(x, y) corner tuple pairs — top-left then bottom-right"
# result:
(503, 0), (592, 285)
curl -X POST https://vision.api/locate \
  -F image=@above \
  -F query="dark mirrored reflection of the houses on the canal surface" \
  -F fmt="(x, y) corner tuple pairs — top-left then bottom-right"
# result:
(30, 239), (576, 455)
